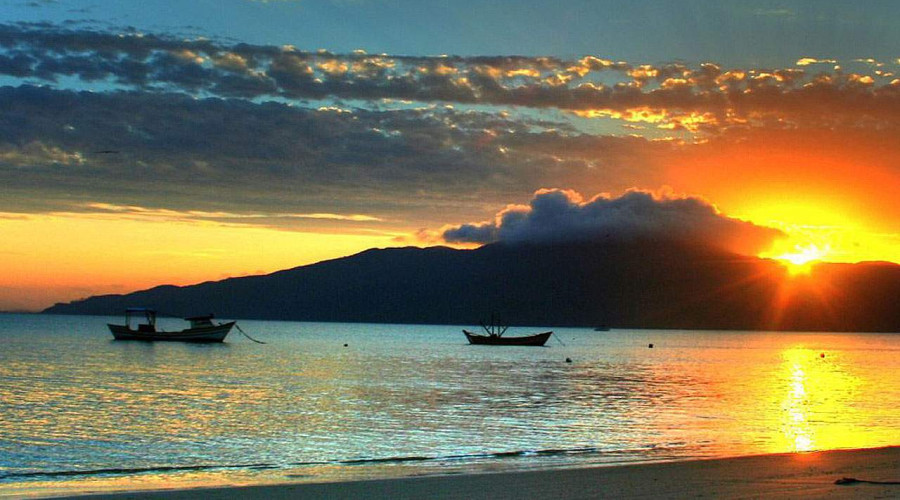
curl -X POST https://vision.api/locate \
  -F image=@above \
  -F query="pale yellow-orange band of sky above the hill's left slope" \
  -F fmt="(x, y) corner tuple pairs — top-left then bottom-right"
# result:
(0, 214), (396, 311)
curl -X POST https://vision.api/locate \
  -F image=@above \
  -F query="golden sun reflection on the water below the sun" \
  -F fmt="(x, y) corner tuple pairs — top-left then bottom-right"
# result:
(640, 338), (897, 456)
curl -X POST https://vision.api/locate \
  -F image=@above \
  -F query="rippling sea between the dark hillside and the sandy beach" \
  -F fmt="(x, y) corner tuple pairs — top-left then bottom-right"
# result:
(0, 314), (900, 497)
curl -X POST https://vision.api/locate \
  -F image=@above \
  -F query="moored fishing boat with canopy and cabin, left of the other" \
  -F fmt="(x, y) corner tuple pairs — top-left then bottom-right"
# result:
(106, 307), (235, 342)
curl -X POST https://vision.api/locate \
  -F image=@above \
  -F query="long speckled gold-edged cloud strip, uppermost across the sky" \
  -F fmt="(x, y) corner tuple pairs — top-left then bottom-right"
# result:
(0, 23), (900, 133)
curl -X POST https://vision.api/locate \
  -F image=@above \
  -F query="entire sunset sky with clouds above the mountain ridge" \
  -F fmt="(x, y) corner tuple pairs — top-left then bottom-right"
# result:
(0, 0), (900, 310)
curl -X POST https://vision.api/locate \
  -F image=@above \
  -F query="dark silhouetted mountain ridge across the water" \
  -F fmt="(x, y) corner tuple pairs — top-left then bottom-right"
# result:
(44, 242), (900, 331)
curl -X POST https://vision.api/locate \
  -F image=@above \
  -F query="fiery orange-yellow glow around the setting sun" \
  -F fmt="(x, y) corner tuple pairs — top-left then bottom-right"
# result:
(666, 131), (900, 271)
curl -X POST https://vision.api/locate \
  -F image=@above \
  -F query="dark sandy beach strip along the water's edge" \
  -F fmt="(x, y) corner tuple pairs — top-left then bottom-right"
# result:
(51, 447), (900, 500)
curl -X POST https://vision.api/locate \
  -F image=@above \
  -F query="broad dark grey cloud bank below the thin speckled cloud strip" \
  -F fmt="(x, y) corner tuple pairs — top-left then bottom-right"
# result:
(0, 86), (671, 226)
